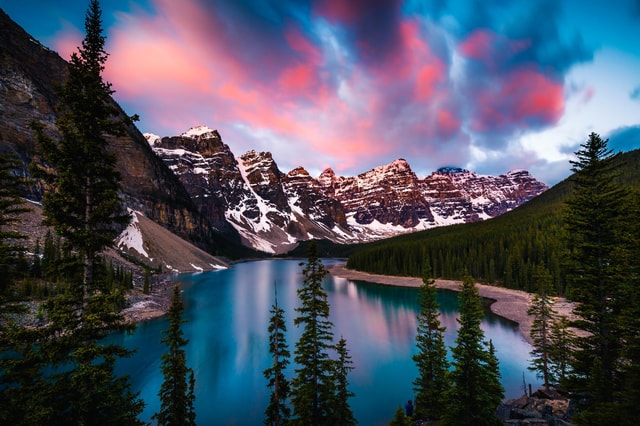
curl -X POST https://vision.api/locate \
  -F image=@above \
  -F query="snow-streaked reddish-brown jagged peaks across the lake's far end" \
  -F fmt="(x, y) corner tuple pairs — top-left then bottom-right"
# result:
(145, 126), (547, 253)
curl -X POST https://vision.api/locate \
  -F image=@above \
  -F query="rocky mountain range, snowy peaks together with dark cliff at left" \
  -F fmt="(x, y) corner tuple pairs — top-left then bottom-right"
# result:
(0, 10), (547, 258)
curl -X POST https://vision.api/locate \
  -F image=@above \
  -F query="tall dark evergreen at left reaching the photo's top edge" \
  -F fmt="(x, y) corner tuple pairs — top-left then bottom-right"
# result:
(33, 0), (129, 298)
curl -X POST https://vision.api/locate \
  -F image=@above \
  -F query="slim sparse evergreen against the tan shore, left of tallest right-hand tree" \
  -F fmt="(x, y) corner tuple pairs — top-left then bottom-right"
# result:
(527, 264), (555, 390)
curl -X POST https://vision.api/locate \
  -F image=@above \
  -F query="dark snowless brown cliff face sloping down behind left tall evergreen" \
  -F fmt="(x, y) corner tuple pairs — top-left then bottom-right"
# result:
(0, 10), (233, 250)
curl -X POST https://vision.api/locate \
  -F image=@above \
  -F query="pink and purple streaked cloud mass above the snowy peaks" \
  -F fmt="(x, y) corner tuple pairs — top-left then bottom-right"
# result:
(50, 0), (600, 181)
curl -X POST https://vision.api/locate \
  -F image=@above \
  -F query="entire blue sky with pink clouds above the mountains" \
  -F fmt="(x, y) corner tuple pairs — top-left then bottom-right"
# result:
(0, 0), (640, 186)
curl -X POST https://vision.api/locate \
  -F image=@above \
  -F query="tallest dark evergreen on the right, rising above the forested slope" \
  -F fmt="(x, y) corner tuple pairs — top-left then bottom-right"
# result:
(565, 133), (627, 410)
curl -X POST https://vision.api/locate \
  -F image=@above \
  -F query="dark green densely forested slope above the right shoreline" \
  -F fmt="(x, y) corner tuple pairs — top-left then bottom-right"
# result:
(347, 150), (640, 293)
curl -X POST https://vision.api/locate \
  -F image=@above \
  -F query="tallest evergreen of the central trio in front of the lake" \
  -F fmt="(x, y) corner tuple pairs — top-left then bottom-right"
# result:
(291, 241), (335, 425)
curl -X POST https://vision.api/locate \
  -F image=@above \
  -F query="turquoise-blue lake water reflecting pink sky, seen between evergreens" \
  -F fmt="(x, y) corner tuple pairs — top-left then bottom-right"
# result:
(113, 260), (539, 425)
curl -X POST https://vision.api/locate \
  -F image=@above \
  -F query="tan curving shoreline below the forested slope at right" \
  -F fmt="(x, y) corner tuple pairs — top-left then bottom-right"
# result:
(327, 263), (573, 344)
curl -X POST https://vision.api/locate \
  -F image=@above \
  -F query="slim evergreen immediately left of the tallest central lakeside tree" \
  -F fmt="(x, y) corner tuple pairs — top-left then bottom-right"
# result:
(264, 282), (291, 426)
